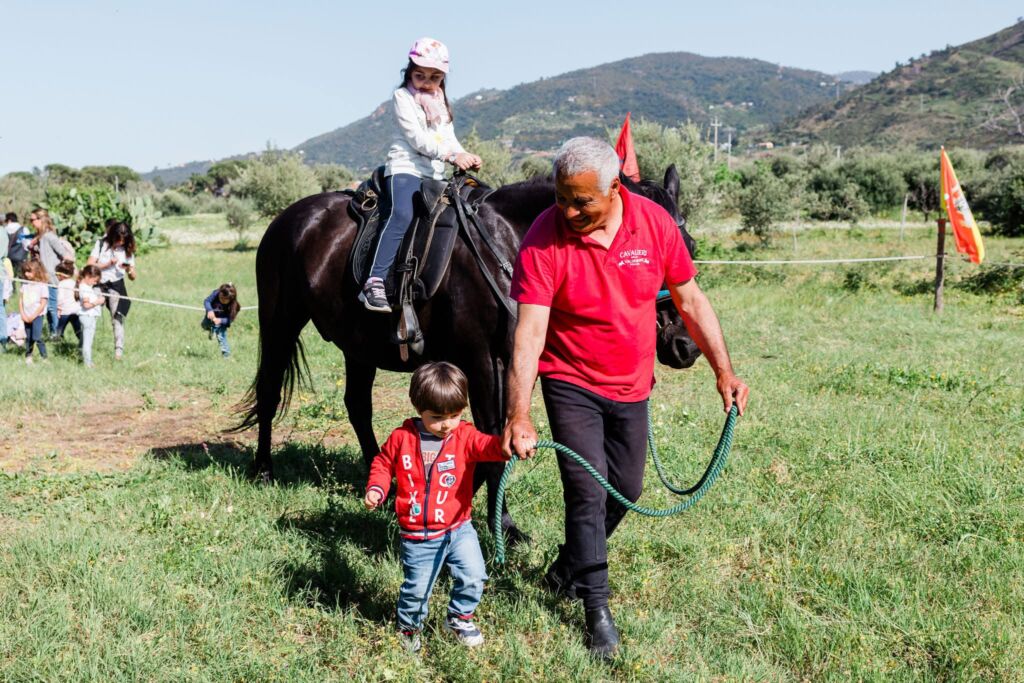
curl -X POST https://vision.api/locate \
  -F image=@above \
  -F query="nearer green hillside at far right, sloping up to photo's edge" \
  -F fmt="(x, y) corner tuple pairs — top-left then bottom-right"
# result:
(778, 22), (1024, 148)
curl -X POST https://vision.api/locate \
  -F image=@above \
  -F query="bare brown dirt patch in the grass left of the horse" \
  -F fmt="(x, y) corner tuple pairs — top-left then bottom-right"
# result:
(0, 393), (254, 473)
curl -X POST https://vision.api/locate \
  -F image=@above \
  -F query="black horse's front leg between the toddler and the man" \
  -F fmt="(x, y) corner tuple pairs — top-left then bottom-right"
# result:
(466, 356), (528, 546)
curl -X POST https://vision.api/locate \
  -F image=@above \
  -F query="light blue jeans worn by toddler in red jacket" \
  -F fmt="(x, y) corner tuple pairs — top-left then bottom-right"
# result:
(398, 520), (487, 631)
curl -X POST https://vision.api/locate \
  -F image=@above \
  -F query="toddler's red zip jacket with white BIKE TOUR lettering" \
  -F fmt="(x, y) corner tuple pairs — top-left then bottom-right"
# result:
(367, 418), (508, 541)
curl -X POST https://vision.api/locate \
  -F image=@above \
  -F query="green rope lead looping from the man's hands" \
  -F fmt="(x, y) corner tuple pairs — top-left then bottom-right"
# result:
(494, 403), (739, 564)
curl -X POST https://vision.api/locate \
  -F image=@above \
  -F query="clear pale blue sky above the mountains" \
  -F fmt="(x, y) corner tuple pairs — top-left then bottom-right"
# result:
(0, 0), (1024, 173)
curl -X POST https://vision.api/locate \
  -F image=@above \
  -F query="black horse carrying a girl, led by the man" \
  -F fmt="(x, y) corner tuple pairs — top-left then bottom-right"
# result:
(239, 166), (699, 538)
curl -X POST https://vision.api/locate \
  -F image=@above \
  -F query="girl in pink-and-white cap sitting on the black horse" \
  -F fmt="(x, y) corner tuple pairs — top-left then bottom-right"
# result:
(359, 38), (481, 312)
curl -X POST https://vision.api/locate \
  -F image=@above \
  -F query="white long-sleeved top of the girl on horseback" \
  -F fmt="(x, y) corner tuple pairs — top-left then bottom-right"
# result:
(384, 87), (465, 180)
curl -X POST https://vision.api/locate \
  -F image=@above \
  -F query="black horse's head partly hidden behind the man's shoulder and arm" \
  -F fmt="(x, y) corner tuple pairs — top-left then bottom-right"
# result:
(622, 164), (700, 370)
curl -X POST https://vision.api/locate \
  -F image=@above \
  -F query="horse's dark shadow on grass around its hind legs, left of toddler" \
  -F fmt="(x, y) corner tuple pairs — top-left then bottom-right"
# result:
(150, 440), (367, 490)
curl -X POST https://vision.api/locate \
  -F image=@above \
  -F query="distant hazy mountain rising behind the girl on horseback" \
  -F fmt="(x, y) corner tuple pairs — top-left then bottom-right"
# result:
(295, 52), (854, 170)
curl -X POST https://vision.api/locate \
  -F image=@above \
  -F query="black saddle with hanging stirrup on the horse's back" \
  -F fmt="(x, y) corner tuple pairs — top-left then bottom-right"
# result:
(348, 167), (511, 353)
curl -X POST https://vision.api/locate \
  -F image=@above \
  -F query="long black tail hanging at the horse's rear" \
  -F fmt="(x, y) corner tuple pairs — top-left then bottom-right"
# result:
(228, 216), (309, 432)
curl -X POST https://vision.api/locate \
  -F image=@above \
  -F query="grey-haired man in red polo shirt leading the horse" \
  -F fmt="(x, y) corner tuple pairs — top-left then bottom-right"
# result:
(504, 137), (749, 657)
